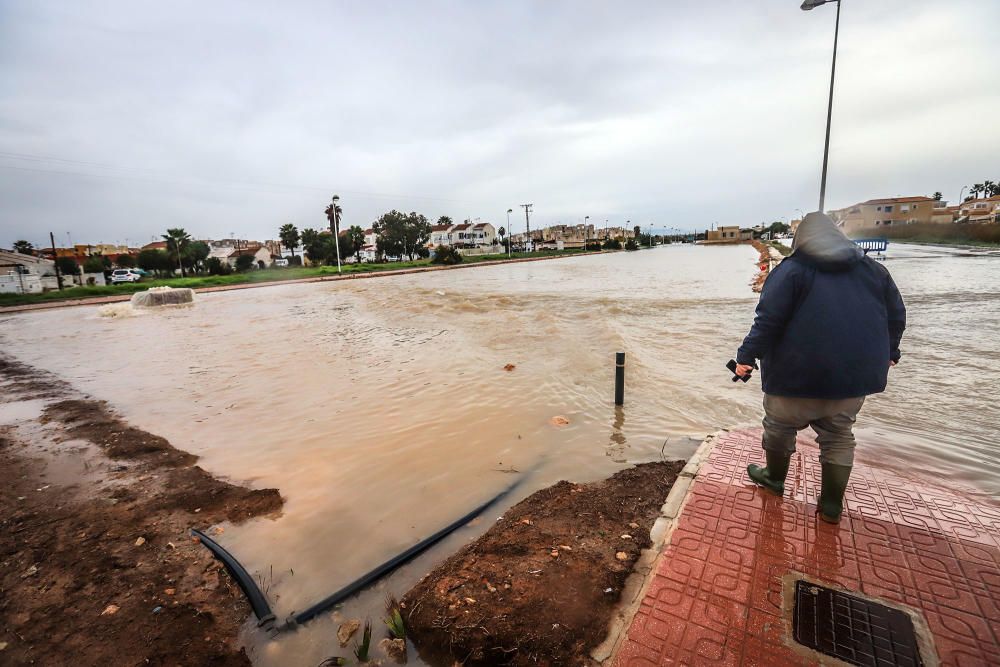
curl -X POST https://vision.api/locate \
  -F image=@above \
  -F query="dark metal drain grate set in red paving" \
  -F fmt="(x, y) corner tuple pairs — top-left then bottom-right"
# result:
(792, 579), (924, 667)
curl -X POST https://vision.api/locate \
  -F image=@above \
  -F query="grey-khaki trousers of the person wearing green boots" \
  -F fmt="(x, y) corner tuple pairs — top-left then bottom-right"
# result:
(761, 394), (865, 466)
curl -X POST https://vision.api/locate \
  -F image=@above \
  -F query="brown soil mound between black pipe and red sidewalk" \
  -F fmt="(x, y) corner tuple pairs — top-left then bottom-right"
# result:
(402, 461), (684, 665)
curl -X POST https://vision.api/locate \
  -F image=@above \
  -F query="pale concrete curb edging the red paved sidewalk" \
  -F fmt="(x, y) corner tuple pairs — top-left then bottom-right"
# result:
(590, 430), (727, 665)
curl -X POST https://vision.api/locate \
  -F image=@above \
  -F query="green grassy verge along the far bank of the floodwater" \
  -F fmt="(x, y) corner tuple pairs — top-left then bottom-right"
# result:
(0, 250), (582, 306)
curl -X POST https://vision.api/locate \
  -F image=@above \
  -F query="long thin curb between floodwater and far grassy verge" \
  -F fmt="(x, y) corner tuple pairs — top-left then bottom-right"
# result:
(0, 250), (608, 315)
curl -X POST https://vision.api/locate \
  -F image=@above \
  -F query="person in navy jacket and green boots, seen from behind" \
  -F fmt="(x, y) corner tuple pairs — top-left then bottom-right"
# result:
(736, 212), (906, 523)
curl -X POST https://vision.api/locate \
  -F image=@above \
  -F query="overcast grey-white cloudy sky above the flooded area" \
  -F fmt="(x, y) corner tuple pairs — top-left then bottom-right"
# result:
(0, 0), (1000, 247)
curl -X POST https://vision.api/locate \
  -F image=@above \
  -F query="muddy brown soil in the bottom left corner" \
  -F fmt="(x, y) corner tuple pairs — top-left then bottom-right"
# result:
(0, 357), (282, 665)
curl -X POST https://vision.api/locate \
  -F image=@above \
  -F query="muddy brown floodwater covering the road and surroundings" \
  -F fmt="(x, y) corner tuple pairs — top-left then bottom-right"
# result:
(0, 245), (1000, 665)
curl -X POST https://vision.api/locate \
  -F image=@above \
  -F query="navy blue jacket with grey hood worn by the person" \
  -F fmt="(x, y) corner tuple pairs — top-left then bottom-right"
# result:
(736, 212), (906, 399)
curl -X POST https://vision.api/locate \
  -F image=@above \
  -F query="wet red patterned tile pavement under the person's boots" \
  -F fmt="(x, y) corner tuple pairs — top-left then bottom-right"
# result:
(613, 430), (1000, 667)
